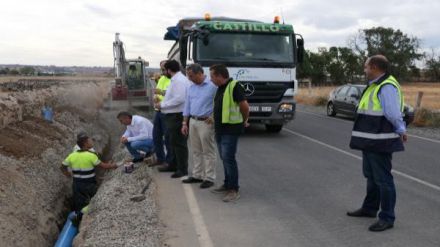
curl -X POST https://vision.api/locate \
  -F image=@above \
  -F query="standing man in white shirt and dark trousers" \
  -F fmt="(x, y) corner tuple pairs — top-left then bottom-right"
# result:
(155, 60), (191, 178)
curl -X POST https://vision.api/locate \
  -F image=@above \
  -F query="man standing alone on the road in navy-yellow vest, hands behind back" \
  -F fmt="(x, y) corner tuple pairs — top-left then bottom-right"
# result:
(347, 55), (407, 232)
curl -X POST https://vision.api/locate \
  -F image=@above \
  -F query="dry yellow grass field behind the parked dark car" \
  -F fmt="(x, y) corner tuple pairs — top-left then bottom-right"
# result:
(296, 83), (440, 110)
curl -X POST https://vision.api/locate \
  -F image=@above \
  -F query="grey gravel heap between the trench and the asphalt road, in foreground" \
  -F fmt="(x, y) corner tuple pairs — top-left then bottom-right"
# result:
(74, 157), (162, 247)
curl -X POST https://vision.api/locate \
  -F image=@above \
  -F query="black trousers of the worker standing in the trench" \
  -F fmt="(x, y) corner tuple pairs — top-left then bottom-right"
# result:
(72, 180), (98, 212)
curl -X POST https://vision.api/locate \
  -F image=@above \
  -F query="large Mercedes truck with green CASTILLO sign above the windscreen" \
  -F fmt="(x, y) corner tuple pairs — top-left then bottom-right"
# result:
(164, 15), (304, 132)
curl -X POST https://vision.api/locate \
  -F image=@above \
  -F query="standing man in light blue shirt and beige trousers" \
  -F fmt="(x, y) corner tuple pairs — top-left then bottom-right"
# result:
(182, 64), (217, 189)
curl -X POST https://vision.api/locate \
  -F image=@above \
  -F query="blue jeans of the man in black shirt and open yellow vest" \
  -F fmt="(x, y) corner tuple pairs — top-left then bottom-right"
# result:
(215, 134), (239, 191)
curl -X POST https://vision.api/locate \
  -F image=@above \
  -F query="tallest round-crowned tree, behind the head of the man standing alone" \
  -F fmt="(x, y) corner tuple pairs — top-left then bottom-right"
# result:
(351, 27), (424, 79)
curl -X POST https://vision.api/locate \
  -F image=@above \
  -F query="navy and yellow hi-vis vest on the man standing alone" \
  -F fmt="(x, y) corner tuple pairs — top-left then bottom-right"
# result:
(350, 75), (404, 153)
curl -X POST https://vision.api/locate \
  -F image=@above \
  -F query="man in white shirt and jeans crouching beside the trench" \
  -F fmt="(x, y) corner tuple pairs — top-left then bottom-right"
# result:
(117, 112), (153, 163)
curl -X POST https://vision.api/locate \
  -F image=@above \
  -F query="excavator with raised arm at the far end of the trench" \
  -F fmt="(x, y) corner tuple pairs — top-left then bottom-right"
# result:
(111, 33), (153, 108)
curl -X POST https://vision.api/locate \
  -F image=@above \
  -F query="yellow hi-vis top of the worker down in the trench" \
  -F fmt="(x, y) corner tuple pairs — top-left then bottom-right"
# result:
(63, 150), (101, 182)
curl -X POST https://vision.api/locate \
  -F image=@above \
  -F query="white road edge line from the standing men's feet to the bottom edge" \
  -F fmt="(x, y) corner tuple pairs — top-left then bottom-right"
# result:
(182, 184), (214, 247)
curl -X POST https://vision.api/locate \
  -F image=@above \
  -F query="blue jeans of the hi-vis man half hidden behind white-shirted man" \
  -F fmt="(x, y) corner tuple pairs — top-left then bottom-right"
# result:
(153, 111), (172, 163)
